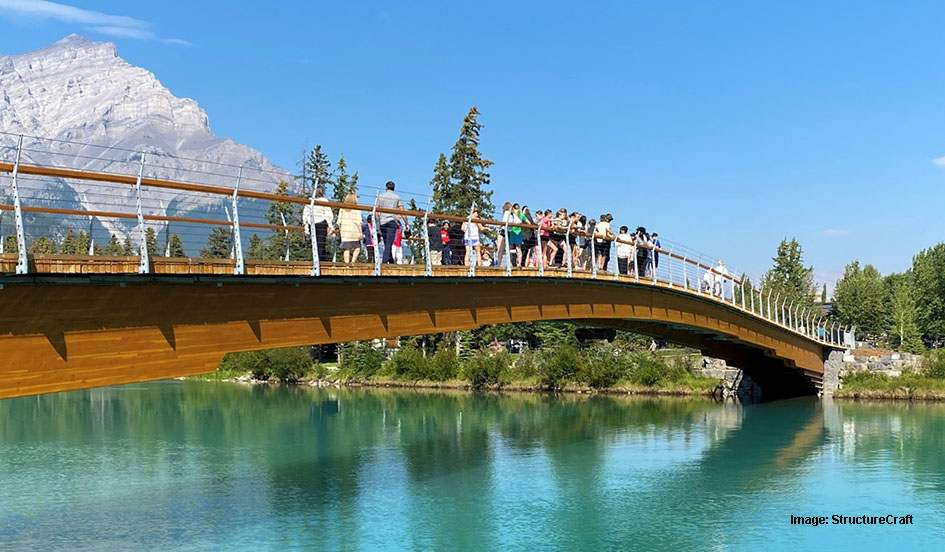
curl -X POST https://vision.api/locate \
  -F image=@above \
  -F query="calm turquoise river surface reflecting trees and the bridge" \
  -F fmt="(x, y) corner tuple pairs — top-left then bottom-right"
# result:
(0, 381), (945, 551)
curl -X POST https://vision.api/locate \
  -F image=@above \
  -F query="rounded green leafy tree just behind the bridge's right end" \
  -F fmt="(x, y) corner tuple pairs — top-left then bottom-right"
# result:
(833, 261), (887, 335)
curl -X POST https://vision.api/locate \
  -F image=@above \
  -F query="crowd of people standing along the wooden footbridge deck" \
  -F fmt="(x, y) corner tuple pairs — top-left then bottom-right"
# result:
(302, 182), (680, 278)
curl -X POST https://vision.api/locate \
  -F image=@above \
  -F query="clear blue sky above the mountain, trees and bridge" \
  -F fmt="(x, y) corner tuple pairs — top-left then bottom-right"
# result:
(0, 0), (945, 282)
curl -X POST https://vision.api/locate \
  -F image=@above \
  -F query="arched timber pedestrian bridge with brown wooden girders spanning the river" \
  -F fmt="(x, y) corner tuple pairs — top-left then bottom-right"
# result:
(0, 138), (850, 398)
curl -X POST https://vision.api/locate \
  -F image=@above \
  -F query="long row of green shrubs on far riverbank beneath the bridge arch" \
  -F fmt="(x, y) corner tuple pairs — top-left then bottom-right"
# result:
(203, 340), (719, 395)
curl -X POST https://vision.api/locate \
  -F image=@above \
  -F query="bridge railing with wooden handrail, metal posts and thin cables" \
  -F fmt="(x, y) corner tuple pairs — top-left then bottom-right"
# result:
(0, 133), (852, 346)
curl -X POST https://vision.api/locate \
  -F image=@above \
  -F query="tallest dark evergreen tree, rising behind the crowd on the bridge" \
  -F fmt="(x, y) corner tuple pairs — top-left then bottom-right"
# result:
(431, 106), (495, 218)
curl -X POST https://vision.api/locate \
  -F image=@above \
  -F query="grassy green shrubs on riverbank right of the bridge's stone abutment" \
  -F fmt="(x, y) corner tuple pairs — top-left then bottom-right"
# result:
(834, 349), (945, 400)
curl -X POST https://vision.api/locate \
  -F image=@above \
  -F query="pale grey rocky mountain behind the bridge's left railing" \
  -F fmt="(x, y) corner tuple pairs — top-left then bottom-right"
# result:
(0, 35), (290, 248)
